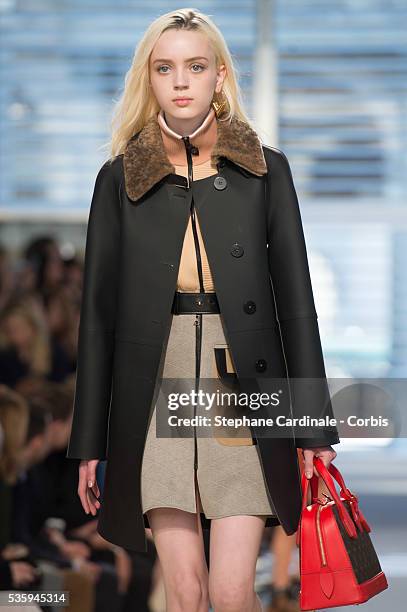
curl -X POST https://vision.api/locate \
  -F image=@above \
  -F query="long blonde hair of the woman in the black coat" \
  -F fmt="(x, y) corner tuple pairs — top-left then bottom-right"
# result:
(102, 8), (250, 161)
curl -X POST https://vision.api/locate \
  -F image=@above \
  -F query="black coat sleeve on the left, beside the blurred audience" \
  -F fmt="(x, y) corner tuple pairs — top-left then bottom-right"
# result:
(66, 162), (120, 460)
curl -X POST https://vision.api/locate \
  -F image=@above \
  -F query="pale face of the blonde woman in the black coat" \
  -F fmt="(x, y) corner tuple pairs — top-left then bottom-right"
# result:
(149, 29), (226, 135)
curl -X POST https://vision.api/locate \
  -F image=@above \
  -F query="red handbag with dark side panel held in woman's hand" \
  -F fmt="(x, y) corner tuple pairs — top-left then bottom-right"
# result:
(296, 457), (388, 610)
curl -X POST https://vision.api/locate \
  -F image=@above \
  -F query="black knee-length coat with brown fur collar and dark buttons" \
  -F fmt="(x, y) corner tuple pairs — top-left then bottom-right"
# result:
(67, 116), (339, 551)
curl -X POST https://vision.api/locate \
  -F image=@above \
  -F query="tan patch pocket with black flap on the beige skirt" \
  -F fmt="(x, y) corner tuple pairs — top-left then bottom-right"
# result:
(212, 344), (255, 446)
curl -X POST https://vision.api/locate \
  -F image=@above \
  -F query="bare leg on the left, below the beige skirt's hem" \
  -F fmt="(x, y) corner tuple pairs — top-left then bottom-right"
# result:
(147, 476), (209, 612)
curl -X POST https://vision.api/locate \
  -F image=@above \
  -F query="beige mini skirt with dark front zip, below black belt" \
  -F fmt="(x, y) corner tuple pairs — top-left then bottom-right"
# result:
(141, 314), (276, 519)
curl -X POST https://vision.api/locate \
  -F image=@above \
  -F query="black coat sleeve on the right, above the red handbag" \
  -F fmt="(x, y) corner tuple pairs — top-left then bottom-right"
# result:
(265, 147), (340, 448)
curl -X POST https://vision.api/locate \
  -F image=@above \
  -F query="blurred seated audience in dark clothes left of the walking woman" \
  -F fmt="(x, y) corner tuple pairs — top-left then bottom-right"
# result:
(0, 236), (157, 612)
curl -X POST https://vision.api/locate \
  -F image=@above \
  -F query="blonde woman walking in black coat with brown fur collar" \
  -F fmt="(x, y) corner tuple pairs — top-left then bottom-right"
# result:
(67, 8), (339, 612)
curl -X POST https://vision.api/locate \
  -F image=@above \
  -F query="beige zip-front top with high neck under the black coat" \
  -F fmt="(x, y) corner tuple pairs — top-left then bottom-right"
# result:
(157, 106), (217, 292)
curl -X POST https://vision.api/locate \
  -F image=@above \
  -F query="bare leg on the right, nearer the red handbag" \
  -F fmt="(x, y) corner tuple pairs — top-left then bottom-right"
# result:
(209, 515), (266, 612)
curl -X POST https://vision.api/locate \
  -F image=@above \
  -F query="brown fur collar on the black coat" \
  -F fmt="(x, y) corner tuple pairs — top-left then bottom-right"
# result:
(123, 115), (267, 200)
